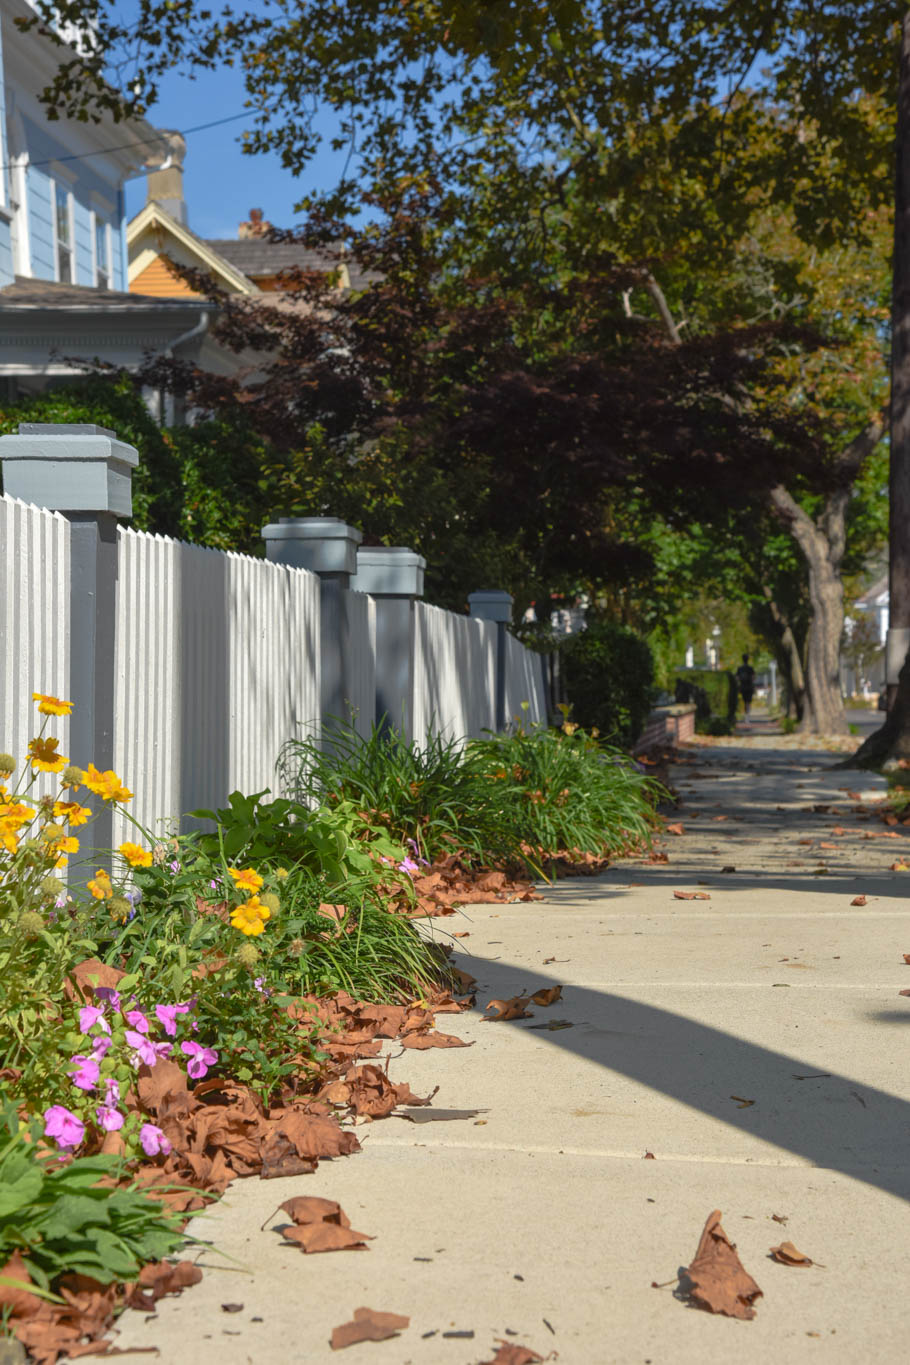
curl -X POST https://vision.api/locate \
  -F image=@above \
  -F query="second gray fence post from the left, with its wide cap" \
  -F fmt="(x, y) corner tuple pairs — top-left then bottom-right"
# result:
(262, 516), (363, 737)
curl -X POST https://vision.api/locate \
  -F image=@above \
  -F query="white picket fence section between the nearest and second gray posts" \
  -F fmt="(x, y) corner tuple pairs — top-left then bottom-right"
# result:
(115, 530), (319, 842)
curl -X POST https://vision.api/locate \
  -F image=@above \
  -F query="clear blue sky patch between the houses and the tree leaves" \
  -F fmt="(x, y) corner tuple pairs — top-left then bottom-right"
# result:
(126, 53), (344, 238)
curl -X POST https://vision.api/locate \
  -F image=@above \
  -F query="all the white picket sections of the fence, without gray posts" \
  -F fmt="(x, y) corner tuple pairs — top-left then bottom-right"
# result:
(0, 495), (547, 844)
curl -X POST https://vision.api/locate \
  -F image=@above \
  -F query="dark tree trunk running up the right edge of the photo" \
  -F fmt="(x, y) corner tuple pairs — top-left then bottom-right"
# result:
(850, 12), (910, 767)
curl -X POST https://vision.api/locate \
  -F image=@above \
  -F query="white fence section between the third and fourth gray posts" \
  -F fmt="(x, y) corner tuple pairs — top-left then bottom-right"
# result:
(411, 602), (497, 743)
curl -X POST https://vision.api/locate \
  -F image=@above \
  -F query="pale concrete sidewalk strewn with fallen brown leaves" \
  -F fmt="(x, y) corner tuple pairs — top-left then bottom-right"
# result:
(111, 737), (910, 1365)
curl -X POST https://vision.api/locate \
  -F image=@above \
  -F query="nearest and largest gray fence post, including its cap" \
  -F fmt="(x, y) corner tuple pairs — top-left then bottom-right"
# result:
(0, 422), (139, 883)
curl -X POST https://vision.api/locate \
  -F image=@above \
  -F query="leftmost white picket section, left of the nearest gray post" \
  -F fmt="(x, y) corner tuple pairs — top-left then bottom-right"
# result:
(0, 494), (70, 792)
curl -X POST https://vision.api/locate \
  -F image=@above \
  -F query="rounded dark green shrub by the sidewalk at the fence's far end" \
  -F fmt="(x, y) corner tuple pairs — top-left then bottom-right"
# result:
(559, 621), (654, 745)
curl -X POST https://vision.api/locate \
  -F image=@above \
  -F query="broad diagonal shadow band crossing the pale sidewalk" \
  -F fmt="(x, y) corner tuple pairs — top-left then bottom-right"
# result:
(457, 954), (910, 1200)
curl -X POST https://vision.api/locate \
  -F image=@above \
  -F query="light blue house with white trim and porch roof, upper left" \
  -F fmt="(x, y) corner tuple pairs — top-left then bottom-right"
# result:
(0, 0), (228, 401)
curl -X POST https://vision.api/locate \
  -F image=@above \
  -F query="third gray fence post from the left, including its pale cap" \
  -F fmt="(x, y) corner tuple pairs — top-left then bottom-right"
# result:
(351, 545), (427, 743)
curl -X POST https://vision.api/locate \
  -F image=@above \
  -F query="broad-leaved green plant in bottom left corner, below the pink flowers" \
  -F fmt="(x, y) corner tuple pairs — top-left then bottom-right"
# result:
(0, 1103), (186, 1290)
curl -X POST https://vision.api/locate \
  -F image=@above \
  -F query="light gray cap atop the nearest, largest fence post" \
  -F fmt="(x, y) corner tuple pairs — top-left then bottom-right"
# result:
(0, 422), (139, 516)
